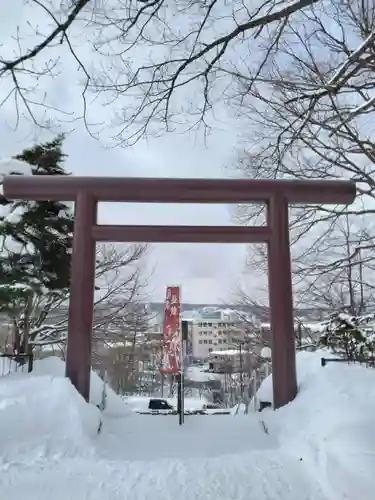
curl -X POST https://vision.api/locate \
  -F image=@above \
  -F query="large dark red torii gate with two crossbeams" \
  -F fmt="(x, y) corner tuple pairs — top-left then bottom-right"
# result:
(3, 175), (356, 408)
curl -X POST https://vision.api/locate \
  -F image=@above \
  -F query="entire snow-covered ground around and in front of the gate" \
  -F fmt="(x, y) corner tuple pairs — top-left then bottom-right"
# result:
(0, 353), (375, 500)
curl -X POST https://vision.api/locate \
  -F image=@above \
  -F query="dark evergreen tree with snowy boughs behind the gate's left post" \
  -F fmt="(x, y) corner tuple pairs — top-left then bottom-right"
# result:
(0, 135), (74, 356)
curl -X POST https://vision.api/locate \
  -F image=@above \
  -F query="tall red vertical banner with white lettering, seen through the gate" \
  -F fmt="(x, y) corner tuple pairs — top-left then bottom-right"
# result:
(160, 286), (182, 373)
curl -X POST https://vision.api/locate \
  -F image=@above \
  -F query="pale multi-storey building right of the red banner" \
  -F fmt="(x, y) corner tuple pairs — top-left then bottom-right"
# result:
(191, 308), (250, 361)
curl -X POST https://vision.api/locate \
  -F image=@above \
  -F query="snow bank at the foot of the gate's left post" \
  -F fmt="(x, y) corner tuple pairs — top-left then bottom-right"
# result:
(0, 374), (100, 464)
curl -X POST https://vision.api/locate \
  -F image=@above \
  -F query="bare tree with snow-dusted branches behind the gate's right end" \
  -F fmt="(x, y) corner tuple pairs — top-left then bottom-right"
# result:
(226, 0), (375, 310)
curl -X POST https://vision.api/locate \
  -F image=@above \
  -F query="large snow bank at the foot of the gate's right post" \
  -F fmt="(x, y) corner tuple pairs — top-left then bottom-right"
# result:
(257, 351), (375, 500)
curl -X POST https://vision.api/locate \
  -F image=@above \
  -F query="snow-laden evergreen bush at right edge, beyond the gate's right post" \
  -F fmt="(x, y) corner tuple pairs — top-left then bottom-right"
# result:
(320, 313), (375, 366)
